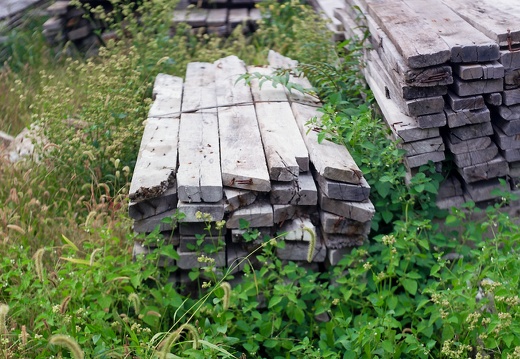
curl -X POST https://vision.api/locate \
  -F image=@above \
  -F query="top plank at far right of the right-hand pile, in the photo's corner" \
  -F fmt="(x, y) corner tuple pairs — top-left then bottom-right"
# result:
(442, 0), (520, 46)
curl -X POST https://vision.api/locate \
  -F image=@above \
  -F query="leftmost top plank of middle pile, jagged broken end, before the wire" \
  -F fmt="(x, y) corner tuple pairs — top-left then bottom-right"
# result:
(129, 118), (179, 201)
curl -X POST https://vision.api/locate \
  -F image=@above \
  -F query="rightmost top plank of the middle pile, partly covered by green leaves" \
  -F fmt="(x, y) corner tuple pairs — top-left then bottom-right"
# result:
(291, 103), (363, 184)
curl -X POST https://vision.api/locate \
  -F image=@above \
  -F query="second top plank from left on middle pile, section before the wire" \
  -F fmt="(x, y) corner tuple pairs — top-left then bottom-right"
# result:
(177, 112), (223, 202)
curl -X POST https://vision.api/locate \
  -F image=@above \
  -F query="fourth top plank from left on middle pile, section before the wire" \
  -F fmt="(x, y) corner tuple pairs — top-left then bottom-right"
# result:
(255, 101), (309, 181)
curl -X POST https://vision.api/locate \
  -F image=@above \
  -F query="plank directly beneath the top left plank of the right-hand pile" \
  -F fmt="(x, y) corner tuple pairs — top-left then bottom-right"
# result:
(366, 16), (453, 87)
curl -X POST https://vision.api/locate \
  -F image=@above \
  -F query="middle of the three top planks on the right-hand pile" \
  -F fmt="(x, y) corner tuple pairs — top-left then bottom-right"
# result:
(403, 0), (500, 63)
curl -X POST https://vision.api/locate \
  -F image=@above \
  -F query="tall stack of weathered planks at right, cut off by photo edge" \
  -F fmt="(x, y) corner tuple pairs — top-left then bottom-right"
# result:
(316, 0), (520, 208)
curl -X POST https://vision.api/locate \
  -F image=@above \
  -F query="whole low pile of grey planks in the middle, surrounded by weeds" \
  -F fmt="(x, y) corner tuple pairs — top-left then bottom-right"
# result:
(129, 52), (374, 270)
